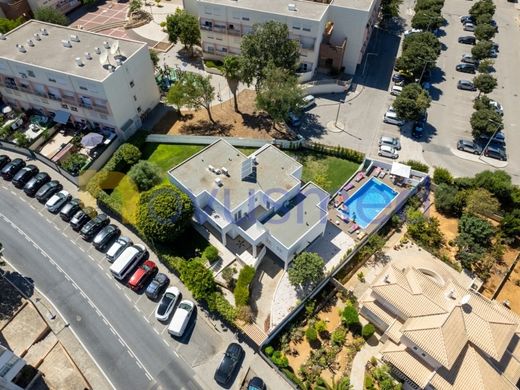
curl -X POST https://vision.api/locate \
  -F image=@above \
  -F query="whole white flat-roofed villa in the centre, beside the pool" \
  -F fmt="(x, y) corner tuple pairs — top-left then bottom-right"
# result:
(168, 139), (329, 267)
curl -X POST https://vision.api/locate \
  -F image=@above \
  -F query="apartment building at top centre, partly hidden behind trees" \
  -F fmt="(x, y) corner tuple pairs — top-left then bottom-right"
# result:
(183, 0), (380, 77)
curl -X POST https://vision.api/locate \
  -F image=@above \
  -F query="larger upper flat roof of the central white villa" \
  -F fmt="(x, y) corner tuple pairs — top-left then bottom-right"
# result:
(168, 139), (301, 211)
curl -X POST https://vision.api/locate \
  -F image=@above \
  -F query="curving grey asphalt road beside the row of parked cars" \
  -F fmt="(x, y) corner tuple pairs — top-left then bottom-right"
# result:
(0, 187), (201, 390)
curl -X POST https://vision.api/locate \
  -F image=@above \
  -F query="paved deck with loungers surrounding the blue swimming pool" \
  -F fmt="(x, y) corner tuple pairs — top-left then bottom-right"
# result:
(328, 169), (411, 241)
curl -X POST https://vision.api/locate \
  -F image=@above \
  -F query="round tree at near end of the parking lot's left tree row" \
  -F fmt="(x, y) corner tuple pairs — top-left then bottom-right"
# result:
(392, 83), (431, 121)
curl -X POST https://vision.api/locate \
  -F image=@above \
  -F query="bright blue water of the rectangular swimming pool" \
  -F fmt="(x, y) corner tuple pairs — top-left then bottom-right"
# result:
(343, 177), (397, 229)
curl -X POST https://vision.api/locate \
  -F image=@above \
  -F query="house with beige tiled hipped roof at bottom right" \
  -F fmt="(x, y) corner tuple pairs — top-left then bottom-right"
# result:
(359, 261), (520, 390)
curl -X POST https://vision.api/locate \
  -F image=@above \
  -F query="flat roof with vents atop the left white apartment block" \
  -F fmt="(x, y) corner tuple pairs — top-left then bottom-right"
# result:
(0, 19), (146, 81)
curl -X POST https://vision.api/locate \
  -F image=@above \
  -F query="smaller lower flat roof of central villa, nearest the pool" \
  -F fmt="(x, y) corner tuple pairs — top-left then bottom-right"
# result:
(264, 183), (330, 248)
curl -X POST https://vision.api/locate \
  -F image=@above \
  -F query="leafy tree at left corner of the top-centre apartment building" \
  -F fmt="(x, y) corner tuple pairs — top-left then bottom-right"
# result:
(166, 8), (200, 55)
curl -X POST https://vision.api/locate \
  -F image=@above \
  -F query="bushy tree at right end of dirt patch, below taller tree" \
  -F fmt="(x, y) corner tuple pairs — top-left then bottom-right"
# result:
(256, 65), (303, 128)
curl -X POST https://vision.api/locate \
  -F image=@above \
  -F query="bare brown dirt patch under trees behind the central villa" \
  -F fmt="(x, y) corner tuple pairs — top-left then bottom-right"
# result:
(153, 90), (296, 139)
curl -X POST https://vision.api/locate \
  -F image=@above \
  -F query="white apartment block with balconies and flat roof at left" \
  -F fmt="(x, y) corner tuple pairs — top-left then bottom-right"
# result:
(0, 20), (159, 139)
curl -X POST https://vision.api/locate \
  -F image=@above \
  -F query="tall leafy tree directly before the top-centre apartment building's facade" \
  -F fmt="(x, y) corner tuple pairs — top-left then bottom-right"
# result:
(240, 21), (300, 90)
